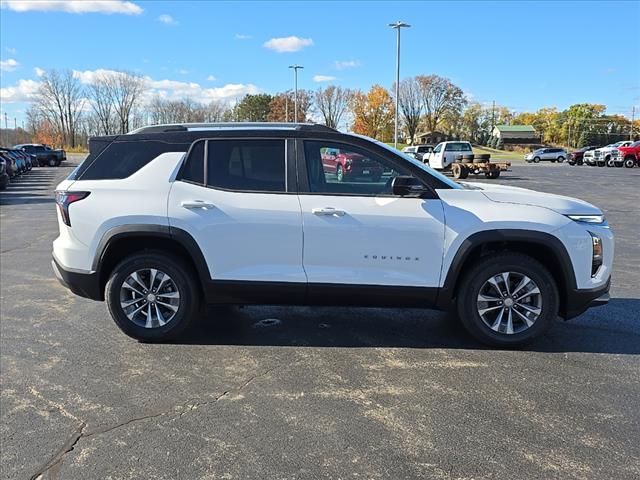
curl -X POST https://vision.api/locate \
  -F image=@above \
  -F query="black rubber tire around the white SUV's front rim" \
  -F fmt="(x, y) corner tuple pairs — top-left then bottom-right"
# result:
(456, 252), (560, 347)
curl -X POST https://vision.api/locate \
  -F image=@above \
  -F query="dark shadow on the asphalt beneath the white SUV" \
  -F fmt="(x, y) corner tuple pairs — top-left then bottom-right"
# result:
(179, 298), (640, 355)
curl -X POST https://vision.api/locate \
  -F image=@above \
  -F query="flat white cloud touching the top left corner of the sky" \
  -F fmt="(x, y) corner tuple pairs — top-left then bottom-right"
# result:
(0, 0), (143, 15)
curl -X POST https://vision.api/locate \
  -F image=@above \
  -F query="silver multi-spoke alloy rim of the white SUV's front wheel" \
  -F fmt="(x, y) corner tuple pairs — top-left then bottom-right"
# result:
(477, 272), (542, 335)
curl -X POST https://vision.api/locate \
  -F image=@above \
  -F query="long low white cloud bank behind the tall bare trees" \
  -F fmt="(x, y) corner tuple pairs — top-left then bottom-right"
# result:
(73, 69), (260, 103)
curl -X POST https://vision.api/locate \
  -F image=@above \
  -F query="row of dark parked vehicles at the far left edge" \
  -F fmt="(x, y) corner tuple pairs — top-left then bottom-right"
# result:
(0, 143), (67, 190)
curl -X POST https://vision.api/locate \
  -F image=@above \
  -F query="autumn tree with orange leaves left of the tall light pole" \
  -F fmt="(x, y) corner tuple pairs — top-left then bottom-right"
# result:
(351, 85), (395, 141)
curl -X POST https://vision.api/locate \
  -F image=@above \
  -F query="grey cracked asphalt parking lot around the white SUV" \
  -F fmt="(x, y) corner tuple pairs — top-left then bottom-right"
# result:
(0, 157), (640, 480)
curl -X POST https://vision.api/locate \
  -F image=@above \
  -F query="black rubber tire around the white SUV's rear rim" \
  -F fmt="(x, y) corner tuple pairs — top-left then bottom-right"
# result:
(105, 251), (201, 342)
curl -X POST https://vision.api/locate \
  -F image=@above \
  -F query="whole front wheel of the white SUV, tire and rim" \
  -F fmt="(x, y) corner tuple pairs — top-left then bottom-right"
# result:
(457, 253), (559, 346)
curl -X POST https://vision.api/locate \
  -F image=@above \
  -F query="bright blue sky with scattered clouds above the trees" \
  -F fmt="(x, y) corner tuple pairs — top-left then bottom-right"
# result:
(0, 0), (640, 126)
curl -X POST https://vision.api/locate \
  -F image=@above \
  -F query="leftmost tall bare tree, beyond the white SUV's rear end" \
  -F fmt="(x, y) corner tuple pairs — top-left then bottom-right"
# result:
(35, 70), (84, 147)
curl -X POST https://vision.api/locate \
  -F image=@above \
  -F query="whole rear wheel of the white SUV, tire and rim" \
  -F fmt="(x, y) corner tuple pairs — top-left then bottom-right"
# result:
(105, 252), (200, 342)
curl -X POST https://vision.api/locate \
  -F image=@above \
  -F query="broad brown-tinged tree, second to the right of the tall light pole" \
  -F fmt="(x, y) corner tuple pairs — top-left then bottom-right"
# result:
(416, 75), (466, 132)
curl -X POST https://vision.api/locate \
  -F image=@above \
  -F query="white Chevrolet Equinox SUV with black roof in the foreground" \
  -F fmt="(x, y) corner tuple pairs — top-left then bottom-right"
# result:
(53, 124), (613, 345)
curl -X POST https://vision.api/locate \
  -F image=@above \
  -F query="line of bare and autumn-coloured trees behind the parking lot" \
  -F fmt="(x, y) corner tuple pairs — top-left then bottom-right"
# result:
(22, 70), (640, 148)
